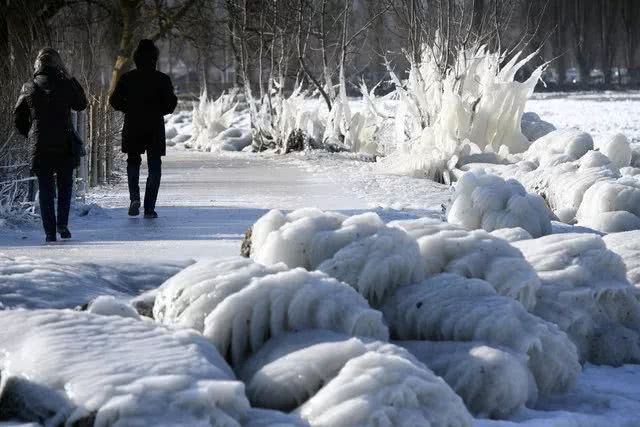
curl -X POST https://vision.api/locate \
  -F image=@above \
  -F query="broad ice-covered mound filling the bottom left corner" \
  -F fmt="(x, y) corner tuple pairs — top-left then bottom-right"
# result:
(0, 310), (249, 427)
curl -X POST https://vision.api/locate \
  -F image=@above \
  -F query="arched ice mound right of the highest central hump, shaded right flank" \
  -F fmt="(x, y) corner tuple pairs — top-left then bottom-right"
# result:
(389, 218), (540, 310)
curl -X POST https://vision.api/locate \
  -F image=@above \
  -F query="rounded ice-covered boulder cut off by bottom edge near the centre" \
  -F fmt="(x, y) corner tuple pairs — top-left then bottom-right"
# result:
(296, 352), (472, 427)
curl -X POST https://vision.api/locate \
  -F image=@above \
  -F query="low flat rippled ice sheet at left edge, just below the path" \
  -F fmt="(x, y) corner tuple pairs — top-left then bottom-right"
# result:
(0, 254), (188, 308)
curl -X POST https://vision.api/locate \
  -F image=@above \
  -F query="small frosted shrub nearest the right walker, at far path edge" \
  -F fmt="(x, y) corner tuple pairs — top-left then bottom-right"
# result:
(186, 90), (249, 151)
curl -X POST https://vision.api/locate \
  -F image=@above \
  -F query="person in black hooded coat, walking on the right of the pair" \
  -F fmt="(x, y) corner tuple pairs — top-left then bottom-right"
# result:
(109, 40), (178, 218)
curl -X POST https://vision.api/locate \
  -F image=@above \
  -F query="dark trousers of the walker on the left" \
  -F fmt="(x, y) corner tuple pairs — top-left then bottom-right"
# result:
(34, 159), (75, 234)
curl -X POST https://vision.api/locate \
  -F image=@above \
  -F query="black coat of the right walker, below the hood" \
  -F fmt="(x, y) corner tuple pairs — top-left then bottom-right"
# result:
(109, 54), (178, 156)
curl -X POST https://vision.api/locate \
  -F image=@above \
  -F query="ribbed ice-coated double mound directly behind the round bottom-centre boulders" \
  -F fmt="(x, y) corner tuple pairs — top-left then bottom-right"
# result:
(154, 258), (388, 367)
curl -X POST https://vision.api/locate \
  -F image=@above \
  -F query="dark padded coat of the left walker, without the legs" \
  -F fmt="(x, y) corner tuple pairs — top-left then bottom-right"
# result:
(14, 67), (87, 166)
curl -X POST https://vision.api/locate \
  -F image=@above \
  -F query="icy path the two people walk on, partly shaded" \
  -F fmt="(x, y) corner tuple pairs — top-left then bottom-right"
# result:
(0, 150), (366, 263)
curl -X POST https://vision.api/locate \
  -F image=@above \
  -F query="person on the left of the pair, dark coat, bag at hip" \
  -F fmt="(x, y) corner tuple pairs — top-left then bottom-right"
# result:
(14, 48), (87, 242)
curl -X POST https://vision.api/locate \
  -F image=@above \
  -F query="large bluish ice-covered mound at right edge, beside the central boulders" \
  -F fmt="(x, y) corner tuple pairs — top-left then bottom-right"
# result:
(514, 233), (640, 365)
